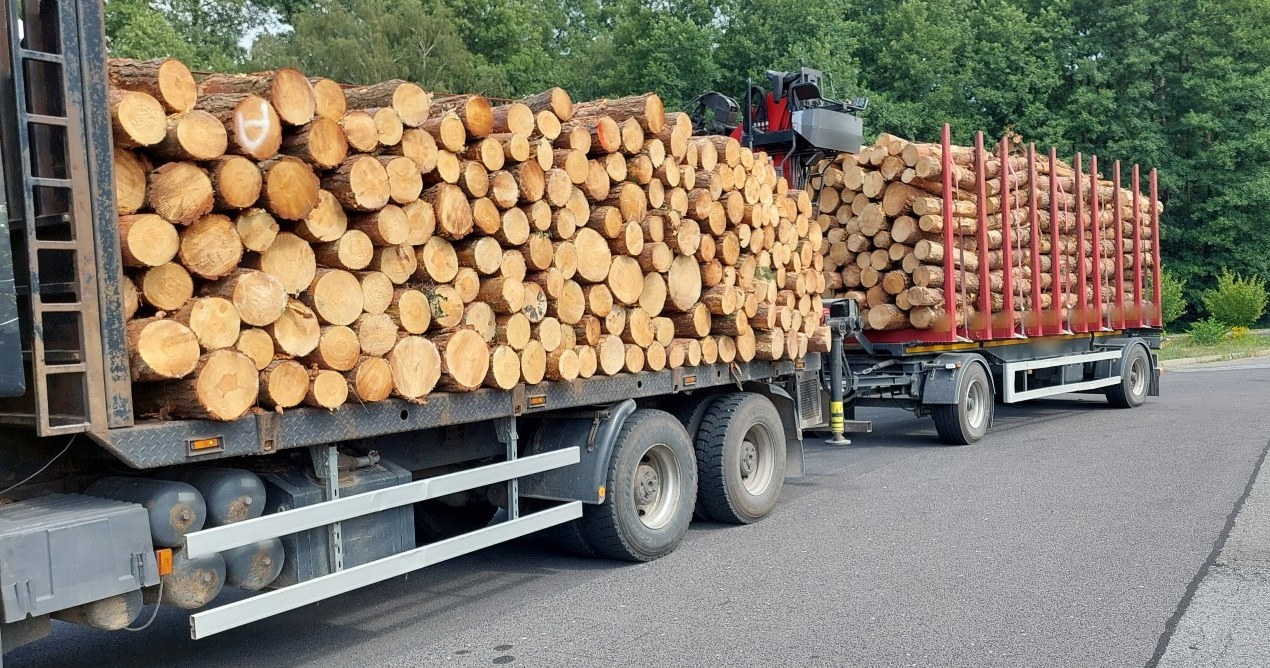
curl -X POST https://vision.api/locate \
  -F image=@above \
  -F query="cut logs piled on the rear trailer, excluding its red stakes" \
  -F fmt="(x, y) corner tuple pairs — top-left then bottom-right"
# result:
(812, 133), (1152, 333)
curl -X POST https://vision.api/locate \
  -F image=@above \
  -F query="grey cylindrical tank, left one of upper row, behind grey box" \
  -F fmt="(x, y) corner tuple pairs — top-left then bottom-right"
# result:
(85, 478), (207, 547)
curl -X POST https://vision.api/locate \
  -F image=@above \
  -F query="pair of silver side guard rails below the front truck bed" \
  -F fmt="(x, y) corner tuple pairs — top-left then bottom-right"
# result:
(185, 446), (582, 640)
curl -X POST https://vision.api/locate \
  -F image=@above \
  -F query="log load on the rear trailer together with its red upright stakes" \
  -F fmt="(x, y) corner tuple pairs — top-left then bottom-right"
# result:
(810, 127), (1162, 340)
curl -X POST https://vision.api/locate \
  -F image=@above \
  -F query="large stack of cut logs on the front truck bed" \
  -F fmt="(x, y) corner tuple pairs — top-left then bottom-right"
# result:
(109, 60), (828, 419)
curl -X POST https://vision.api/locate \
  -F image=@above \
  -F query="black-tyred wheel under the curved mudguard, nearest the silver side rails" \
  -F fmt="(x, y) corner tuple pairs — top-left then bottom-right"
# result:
(578, 409), (697, 561)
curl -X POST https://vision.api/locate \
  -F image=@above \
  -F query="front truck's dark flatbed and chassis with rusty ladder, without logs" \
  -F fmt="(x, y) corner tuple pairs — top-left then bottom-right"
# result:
(0, 0), (823, 650)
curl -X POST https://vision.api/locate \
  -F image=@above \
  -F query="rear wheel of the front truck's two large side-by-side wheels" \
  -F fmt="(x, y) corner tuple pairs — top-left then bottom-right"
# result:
(696, 392), (785, 524)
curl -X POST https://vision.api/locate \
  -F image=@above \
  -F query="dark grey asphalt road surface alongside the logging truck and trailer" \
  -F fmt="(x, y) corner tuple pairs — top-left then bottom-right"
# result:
(5, 364), (1270, 668)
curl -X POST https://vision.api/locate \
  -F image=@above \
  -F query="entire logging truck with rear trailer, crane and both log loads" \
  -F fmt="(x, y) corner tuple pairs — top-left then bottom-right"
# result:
(0, 0), (1160, 650)
